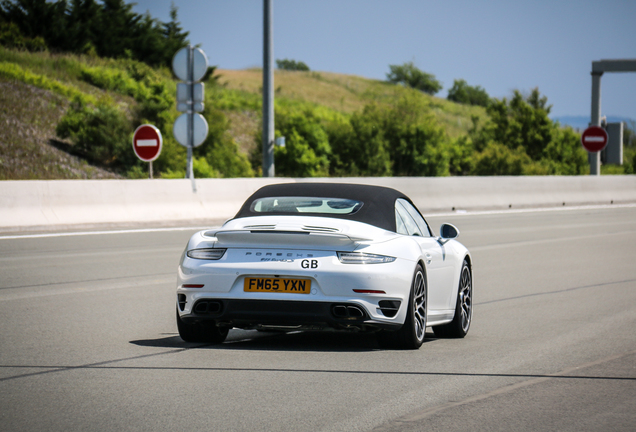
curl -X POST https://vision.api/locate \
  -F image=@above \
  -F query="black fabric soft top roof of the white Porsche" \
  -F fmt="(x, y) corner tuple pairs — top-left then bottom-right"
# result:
(235, 183), (411, 232)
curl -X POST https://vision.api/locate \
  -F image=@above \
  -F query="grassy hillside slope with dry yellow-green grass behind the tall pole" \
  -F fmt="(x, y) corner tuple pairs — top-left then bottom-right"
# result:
(0, 47), (486, 179)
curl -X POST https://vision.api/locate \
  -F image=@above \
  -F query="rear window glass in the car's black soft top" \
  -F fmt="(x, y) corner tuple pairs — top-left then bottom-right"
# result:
(250, 196), (363, 215)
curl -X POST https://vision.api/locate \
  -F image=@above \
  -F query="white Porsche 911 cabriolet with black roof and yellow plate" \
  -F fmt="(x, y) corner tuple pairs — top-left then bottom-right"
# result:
(177, 183), (473, 349)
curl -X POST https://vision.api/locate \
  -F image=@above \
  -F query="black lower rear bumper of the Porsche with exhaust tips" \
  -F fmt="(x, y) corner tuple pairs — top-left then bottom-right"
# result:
(176, 298), (401, 331)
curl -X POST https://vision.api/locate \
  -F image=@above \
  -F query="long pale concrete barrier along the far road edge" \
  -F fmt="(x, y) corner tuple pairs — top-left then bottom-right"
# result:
(0, 175), (636, 231)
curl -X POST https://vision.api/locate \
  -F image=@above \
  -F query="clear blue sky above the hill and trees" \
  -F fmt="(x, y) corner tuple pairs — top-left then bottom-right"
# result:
(134, 0), (636, 119)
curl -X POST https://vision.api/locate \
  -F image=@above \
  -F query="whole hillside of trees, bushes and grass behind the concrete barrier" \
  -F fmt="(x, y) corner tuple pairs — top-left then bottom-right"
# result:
(0, 0), (636, 179)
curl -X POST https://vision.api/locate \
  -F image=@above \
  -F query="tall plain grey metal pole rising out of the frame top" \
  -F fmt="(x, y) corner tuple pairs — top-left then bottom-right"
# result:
(263, 0), (275, 177)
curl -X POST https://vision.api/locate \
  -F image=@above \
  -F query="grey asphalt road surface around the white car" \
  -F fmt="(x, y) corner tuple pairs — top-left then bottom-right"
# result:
(0, 207), (636, 431)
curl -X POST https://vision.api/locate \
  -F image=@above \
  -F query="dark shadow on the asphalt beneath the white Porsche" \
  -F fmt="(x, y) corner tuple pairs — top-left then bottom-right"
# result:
(130, 329), (435, 352)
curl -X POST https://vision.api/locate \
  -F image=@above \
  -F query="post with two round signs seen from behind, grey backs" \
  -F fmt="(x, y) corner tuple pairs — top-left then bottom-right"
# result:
(172, 45), (208, 192)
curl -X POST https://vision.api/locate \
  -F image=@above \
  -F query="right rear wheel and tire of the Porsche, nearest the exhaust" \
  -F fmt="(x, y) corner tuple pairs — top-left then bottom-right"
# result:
(377, 264), (428, 349)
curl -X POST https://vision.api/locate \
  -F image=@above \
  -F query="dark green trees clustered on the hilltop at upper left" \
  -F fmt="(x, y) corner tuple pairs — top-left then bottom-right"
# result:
(0, 0), (188, 66)
